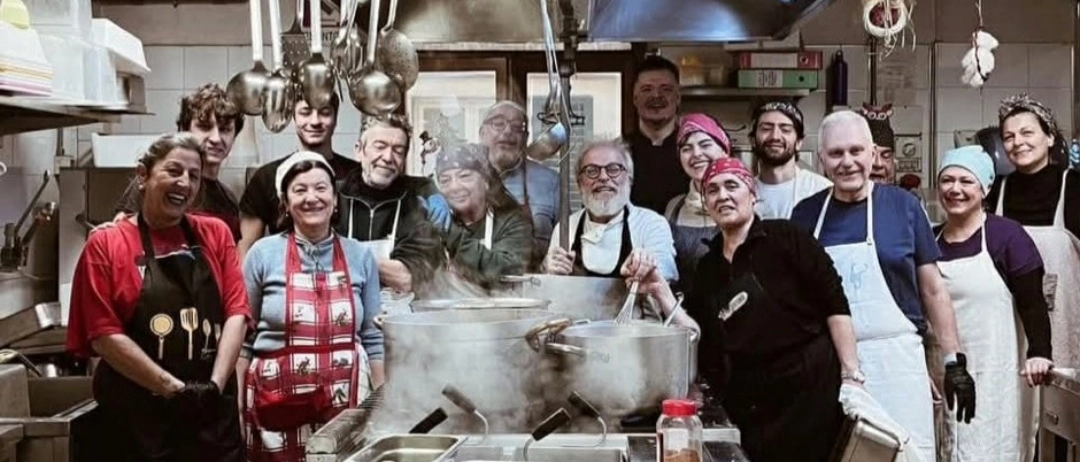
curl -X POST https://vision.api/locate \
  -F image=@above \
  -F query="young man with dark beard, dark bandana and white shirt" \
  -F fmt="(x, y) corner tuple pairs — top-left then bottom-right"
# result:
(751, 101), (833, 219)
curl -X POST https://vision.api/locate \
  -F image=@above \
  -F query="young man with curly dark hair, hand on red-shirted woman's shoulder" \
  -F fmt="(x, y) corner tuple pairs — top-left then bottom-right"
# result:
(116, 83), (244, 240)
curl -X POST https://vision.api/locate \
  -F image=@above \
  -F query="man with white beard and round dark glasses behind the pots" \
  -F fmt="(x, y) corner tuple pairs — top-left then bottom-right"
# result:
(544, 140), (678, 282)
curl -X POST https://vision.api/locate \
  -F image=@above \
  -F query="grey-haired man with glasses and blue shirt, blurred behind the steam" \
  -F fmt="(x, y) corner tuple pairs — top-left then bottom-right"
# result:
(480, 100), (559, 266)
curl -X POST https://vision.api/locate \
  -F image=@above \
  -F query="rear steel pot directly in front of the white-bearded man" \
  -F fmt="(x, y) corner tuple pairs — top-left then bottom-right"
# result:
(501, 274), (627, 321)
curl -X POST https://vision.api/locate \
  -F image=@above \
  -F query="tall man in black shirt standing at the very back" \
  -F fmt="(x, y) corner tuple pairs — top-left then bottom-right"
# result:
(624, 55), (690, 214)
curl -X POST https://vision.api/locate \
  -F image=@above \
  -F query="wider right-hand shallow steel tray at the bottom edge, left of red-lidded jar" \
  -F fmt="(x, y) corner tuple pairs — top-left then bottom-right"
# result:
(456, 434), (627, 462)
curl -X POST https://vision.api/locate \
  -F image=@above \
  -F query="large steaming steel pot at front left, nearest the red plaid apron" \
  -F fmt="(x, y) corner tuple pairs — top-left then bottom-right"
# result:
(382, 309), (565, 431)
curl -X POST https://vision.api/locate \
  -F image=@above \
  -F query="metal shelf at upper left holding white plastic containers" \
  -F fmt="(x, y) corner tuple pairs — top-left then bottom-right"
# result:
(0, 95), (146, 135)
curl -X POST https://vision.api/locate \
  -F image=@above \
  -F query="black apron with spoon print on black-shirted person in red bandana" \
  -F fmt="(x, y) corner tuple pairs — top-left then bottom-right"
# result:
(713, 268), (842, 462)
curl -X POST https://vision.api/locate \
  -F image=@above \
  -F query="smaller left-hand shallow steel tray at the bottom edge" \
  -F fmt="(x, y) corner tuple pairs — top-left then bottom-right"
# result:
(346, 435), (464, 462)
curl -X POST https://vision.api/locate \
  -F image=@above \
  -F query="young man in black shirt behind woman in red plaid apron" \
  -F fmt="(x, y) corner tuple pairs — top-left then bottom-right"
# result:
(237, 94), (360, 261)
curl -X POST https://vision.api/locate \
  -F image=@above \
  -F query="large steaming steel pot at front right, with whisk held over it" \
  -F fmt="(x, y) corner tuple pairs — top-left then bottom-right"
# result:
(532, 320), (698, 417)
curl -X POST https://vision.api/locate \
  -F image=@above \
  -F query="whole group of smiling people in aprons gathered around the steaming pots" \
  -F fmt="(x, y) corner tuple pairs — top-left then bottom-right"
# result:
(68, 56), (1080, 462)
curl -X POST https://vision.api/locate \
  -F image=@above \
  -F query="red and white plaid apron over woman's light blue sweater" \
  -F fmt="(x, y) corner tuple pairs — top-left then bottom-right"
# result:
(244, 234), (372, 462)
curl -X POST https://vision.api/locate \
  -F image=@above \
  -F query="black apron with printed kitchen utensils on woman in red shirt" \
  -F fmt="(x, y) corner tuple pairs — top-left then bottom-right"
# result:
(94, 214), (243, 462)
